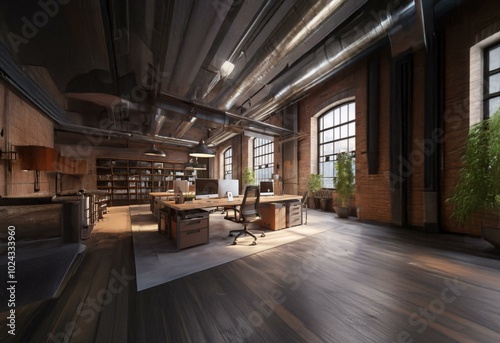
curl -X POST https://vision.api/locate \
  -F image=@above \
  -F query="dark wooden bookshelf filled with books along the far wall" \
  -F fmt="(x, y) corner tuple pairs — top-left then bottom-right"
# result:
(96, 157), (196, 206)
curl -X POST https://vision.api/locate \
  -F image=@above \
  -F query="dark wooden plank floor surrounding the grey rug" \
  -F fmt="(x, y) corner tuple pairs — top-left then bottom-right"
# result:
(0, 207), (500, 343)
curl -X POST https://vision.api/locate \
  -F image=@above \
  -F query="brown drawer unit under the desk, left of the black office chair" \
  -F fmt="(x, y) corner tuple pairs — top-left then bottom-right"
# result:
(172, 211), (209, 250)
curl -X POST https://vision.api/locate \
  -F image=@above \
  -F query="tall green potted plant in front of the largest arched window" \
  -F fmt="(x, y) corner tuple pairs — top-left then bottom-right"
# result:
(333, 152), (355, 218)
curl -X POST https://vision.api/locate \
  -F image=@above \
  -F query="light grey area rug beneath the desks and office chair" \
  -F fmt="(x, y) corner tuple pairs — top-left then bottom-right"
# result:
(130, 205), (334, 291)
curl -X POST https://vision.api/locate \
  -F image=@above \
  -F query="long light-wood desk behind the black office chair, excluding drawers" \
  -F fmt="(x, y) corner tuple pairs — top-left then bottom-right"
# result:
(156, 194), (302, 249)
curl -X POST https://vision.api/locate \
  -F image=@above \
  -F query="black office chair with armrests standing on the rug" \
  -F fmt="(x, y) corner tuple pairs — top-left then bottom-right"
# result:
(224, 186), (266, 245)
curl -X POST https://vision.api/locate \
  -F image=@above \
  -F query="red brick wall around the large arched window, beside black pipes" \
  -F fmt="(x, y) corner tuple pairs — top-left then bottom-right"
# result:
(298, 43), (425, 226)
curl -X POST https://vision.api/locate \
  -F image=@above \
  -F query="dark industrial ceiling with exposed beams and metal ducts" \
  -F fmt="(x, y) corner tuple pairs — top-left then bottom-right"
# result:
(0, 0), (426, 152)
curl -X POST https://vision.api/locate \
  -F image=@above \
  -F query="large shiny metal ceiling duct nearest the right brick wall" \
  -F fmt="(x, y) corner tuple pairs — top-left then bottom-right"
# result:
(247, 1), (416, 120)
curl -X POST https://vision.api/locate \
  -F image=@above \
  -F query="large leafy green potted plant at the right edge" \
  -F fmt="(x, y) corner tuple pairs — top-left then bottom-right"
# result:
(447, 109), (500, 247)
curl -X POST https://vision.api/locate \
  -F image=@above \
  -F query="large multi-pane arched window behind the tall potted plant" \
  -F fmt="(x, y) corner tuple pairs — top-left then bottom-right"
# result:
(318, 101), (356, 188)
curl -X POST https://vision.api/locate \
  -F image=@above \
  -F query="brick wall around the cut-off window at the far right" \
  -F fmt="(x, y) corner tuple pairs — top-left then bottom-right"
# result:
(441, 0), (500, 235)
